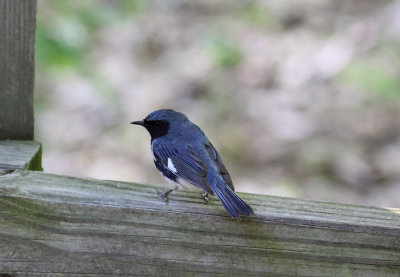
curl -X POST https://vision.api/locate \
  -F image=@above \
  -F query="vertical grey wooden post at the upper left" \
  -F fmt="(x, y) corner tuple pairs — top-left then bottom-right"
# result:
(0, 0), (36, 140)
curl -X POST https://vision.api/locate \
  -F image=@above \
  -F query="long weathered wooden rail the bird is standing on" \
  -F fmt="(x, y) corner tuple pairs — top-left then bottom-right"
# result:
(0, 171), (400, 277)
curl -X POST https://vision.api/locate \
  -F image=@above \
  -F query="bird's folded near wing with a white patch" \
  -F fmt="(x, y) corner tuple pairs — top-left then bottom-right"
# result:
(152, 142), (213, 194)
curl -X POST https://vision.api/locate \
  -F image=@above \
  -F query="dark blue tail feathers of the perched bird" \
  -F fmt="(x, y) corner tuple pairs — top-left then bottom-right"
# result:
(209, 175), (254, 217)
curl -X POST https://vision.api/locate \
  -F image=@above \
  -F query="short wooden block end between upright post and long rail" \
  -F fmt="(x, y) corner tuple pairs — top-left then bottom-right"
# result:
(0, 140), (43, 172)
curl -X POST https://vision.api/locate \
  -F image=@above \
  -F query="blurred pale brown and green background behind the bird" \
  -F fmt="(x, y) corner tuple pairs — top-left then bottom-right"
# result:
(35, 0), (400, 207)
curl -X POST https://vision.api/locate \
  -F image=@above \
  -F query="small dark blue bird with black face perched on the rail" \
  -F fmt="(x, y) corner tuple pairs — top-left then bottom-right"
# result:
(131, 109), (254, 217)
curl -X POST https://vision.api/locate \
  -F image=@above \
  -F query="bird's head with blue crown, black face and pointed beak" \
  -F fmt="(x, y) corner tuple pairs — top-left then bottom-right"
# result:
(131, 109), (187, 139)
